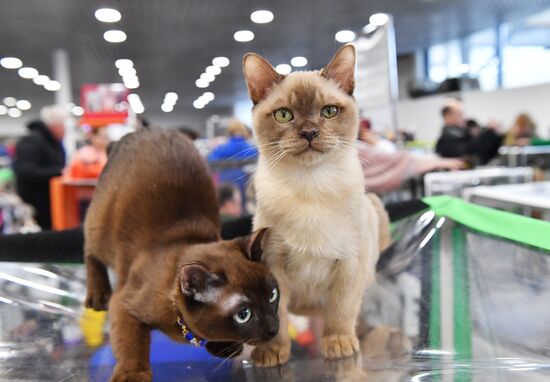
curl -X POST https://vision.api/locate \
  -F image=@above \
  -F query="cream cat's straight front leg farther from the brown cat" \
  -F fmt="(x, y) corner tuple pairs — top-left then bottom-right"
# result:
(321, 260), (366, 359)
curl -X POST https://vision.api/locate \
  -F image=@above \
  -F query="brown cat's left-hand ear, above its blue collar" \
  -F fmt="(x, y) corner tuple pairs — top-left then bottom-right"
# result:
(179, 264), (222, 303)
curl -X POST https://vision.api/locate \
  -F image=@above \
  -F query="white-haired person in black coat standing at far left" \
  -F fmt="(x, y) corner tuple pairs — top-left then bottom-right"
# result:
(13, 106), (69, 229)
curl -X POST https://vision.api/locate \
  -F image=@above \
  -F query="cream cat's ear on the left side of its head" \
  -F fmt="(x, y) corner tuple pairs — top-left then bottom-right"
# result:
(243, 53), (284, 105)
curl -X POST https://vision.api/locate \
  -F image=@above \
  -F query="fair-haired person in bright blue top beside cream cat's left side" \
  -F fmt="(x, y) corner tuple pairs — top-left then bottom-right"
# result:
(208, 119), (258, 203)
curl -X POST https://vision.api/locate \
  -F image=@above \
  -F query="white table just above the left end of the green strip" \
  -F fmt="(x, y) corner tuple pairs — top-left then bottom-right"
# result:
(424, 167), (534, 196)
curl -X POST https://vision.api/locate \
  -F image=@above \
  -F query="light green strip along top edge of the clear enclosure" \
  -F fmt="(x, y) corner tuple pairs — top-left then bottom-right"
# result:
(422, 196), (550, 251)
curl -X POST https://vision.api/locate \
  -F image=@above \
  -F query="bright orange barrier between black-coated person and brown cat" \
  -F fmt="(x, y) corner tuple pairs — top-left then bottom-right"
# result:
(50, 176), (97, 230)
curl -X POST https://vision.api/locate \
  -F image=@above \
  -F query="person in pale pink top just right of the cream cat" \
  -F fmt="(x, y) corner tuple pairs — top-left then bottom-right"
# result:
(357, 121), (464, 194)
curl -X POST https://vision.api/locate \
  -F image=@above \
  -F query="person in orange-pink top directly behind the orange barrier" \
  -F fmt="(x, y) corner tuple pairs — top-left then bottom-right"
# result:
(67, 128), (110, 179)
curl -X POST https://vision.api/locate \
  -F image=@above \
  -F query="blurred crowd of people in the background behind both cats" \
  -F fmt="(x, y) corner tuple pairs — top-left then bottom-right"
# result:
(0, 99), (547, 229)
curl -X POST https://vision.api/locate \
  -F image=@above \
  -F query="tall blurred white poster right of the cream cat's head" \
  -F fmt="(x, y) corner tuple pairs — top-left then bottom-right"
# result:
(354, 18), (398, 132)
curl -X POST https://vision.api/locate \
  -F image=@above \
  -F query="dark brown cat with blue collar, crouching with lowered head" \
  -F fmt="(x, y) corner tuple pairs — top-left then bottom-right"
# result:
(84, 131), (279, 381)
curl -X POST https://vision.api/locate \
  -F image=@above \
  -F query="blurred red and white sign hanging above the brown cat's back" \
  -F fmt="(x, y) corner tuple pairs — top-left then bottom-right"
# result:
(80, 84), (129, 126)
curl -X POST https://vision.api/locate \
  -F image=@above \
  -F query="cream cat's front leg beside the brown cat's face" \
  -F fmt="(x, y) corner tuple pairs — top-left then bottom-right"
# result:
(251, 269), (290, 367)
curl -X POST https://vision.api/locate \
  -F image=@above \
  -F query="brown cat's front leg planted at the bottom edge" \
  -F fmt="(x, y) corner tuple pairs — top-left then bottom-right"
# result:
(109, 292), (153, 382)
